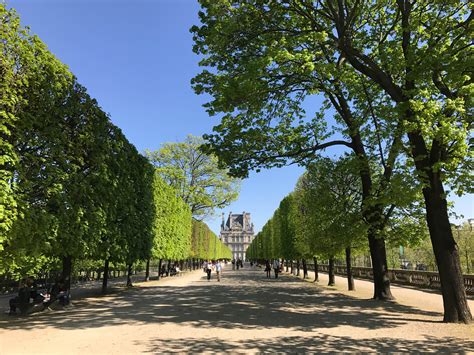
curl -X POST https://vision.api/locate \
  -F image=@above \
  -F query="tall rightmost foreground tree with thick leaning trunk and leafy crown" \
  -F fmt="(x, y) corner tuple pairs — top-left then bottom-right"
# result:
(286, 0), (474, 323)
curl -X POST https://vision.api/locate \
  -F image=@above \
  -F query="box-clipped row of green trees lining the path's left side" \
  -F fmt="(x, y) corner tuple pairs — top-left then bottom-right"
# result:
(0, 5), (228, 290)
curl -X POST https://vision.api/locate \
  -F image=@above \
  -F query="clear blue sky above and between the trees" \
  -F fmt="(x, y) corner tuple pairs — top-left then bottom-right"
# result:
(7, 0), (474, 233)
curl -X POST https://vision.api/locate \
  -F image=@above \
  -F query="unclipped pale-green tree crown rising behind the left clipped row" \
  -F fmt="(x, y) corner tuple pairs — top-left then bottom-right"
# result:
(146, 135), (239, 219)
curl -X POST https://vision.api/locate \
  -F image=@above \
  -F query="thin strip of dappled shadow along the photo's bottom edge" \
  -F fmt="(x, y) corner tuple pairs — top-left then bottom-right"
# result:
(142, 334), (474, 354)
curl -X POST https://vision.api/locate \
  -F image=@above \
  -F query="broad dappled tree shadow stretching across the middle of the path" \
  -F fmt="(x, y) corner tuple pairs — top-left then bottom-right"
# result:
(0, 271), (441, 331)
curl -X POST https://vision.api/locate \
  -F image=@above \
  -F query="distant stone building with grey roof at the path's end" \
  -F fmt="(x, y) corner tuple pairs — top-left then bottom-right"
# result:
(219, 212), (254, 260)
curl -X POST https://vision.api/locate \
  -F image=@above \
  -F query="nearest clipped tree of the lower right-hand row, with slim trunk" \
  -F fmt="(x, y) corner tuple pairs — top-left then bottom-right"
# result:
(294, 156), (367, 290)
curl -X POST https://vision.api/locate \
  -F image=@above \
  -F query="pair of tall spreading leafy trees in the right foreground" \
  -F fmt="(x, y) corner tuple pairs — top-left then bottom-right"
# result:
(192, 0), (474, 322)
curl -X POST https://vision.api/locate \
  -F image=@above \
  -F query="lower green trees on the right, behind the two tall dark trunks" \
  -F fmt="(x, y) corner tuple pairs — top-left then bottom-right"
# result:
(247, 156), (474, 284)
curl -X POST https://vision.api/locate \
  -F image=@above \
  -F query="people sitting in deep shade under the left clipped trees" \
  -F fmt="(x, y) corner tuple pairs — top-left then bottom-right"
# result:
(9, 277), (69, 315)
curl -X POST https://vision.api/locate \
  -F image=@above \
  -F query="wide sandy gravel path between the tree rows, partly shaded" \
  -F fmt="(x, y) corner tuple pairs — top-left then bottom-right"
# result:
(0, 267), (474, 354)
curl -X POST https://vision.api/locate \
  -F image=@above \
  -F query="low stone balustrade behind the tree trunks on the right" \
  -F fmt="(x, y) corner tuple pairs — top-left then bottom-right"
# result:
(293, 264), (474, 295)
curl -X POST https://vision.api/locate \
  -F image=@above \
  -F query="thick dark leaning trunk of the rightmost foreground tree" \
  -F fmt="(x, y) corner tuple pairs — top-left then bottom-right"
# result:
(423, 179), (472, 323)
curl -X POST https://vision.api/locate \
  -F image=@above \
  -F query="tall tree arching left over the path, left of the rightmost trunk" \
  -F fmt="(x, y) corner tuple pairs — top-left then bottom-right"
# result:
(193, 1), (416, 299)
